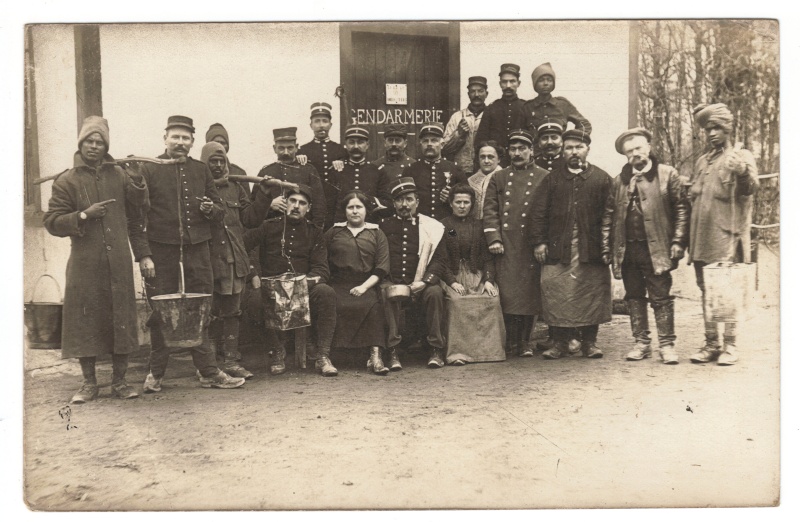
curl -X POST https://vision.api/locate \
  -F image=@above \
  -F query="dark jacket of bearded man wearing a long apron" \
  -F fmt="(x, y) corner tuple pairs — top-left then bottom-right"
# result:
(531, 165), (611, 265)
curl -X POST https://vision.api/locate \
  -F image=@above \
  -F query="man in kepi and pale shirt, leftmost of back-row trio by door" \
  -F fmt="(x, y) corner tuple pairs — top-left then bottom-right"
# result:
(442, 76), (489, 174)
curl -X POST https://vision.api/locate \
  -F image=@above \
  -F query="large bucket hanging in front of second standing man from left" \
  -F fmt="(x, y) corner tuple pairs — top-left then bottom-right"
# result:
(150, 263), (211, 350)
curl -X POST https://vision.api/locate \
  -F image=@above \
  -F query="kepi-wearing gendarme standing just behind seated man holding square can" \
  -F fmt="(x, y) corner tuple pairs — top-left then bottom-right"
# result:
(258, 127), (326, 228)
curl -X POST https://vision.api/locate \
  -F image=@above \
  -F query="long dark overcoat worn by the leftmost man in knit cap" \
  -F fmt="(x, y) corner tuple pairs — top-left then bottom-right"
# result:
(44, 153), (147, 359)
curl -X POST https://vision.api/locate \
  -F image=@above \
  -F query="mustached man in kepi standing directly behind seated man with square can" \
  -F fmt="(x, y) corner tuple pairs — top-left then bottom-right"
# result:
(258, 127), (327, 228)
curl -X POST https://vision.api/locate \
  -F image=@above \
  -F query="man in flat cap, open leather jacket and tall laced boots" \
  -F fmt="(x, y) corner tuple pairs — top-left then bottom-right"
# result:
(603, 127), (689, 364)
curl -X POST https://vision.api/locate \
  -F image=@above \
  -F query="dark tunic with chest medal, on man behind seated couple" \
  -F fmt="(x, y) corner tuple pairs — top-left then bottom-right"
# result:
(403, 155), (467, 221)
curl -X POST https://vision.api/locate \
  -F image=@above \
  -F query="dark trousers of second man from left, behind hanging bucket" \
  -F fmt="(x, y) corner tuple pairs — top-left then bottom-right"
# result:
(145, 241), (219, 379)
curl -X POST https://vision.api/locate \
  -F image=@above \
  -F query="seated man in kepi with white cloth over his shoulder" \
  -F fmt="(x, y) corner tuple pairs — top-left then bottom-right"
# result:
(380, 177), (446, 371)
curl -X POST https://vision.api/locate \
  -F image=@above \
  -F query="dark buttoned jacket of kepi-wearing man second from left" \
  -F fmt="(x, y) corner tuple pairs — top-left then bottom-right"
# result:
(134, 154), (225, 249)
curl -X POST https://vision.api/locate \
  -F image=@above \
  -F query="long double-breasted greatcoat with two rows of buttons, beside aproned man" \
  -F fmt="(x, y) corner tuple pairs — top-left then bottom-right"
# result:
(483, 164), (547, 315)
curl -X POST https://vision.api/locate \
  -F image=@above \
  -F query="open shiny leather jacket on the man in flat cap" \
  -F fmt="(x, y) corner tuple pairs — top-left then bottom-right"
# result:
(603, 160), (689, 279)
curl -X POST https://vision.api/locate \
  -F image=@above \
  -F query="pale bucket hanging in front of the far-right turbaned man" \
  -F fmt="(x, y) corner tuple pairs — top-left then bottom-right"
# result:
(703, 263), (756, 323)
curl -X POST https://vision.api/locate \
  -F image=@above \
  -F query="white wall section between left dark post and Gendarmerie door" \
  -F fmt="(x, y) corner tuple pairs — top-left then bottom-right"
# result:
(100, 23), (339, 175)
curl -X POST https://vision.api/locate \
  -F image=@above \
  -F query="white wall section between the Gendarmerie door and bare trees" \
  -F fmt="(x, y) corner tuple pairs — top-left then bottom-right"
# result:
(461, 21), (629, 176)
